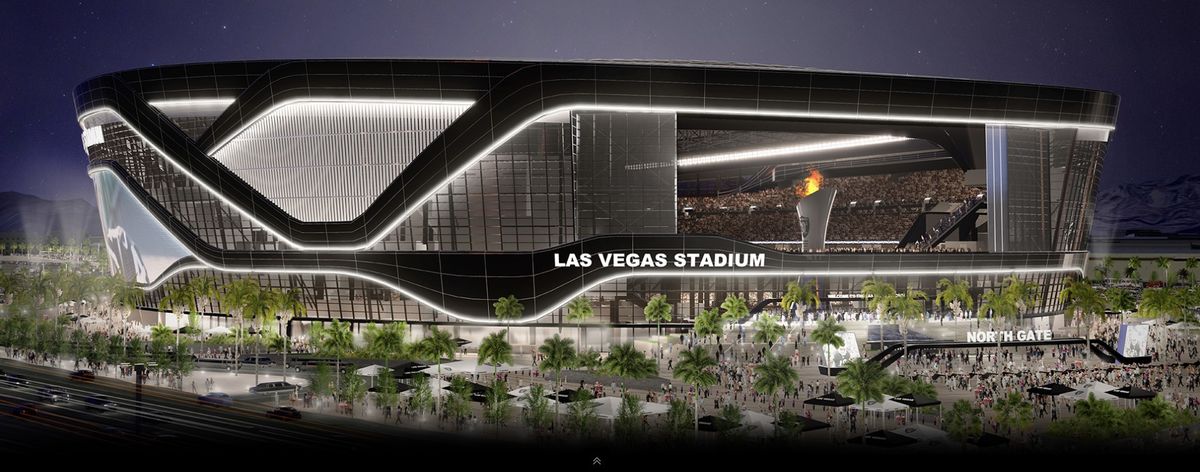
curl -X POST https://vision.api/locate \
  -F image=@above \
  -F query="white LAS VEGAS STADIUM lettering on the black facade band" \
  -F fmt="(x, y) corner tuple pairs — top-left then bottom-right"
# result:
(554, 252), (767, 269)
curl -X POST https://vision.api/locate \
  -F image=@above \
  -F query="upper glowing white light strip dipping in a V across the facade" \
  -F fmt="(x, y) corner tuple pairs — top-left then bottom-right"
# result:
(79, 98), (1116, 251)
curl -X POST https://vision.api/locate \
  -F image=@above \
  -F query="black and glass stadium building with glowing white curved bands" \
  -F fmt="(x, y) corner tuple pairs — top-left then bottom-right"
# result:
(76, 60), (1118, 325)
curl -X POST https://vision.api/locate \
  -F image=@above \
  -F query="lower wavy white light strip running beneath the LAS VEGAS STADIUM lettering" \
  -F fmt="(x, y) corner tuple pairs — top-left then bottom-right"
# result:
(88, 167), (1084, 324)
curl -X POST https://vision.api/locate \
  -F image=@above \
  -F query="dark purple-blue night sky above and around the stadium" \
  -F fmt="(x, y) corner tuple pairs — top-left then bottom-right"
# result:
(0, 0), (1200, 201)
